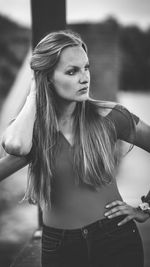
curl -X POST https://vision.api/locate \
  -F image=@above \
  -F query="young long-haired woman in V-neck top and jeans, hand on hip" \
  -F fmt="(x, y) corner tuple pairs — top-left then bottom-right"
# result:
(1, 31), (150, 267)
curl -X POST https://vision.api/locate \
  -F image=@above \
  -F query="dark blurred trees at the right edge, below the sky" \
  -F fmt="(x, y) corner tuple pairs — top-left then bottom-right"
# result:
(120, 26), (150, 91)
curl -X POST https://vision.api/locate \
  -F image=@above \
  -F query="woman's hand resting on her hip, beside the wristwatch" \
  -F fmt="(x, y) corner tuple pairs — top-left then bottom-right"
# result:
(104, 200), (150, 226)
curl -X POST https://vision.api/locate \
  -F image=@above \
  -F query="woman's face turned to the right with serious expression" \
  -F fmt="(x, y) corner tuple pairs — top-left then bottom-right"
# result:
(51, 46), (90, 101)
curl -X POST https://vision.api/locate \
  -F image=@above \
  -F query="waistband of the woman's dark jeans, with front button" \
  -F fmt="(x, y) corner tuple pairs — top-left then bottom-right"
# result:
(43, 215), (133, 238)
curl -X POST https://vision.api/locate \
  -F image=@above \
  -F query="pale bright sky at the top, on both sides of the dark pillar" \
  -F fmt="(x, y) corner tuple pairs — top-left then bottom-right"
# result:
(0, 0), (150, 29)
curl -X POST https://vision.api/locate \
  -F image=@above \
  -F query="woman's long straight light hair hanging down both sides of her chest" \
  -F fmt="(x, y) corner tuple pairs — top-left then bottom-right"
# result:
(26, 31), (134, 204)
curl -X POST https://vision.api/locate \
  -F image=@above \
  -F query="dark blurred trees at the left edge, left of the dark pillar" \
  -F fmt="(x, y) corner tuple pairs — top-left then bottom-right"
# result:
(0, 16), (30, 102)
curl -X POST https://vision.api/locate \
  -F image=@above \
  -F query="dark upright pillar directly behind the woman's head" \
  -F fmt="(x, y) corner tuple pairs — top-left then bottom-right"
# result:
(31, 0), (66, 228)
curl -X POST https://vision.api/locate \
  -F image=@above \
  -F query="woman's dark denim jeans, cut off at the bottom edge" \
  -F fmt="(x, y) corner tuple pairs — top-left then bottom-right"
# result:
(42, 217), (144, 267)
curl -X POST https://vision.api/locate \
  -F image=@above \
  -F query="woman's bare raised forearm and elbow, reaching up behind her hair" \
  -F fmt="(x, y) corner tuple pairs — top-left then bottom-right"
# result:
(2, 79), (36, 156)
